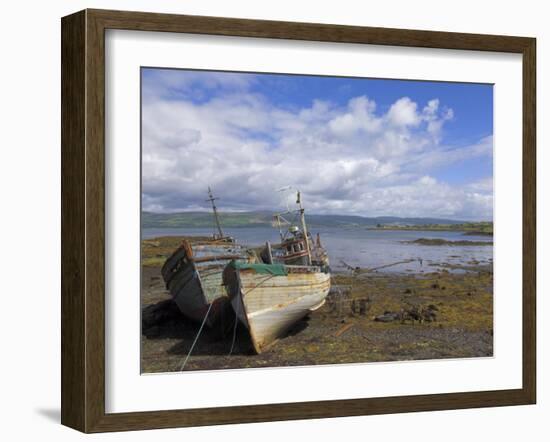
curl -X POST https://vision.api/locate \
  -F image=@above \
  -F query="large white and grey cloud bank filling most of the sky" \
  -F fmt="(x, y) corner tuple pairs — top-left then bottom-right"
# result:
(142, 74), (492, 218)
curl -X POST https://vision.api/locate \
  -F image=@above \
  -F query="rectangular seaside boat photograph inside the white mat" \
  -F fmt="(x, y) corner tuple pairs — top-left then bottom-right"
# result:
(141, 67), (494, 374)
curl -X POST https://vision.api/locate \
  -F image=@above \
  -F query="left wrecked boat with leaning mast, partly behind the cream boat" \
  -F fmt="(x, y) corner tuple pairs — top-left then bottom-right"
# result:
(161, 188), (249, 327)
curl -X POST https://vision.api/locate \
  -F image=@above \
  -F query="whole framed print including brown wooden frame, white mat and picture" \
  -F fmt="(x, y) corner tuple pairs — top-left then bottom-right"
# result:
(62, 10), (536, 432)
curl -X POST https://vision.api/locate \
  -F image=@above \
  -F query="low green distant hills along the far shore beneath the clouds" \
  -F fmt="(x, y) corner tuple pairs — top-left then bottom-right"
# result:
(141, 212), (470, 228)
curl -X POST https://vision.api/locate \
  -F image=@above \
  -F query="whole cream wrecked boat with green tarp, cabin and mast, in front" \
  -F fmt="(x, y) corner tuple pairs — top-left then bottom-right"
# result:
(223, 192), (330, 353)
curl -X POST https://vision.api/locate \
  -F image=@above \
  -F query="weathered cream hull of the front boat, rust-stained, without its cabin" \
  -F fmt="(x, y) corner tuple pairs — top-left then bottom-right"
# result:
(224, 266), (330, 353)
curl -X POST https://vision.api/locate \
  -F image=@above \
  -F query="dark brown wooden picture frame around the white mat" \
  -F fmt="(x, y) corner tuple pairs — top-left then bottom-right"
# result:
(61, 10), (536, 432)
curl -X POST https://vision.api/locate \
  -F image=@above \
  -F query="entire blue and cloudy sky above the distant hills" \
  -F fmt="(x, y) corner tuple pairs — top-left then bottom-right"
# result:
(142, 68), (493, 220)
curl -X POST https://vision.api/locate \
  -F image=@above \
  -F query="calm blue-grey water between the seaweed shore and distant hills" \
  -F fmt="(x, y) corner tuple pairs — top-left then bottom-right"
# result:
(143, 227), (493, 273)
